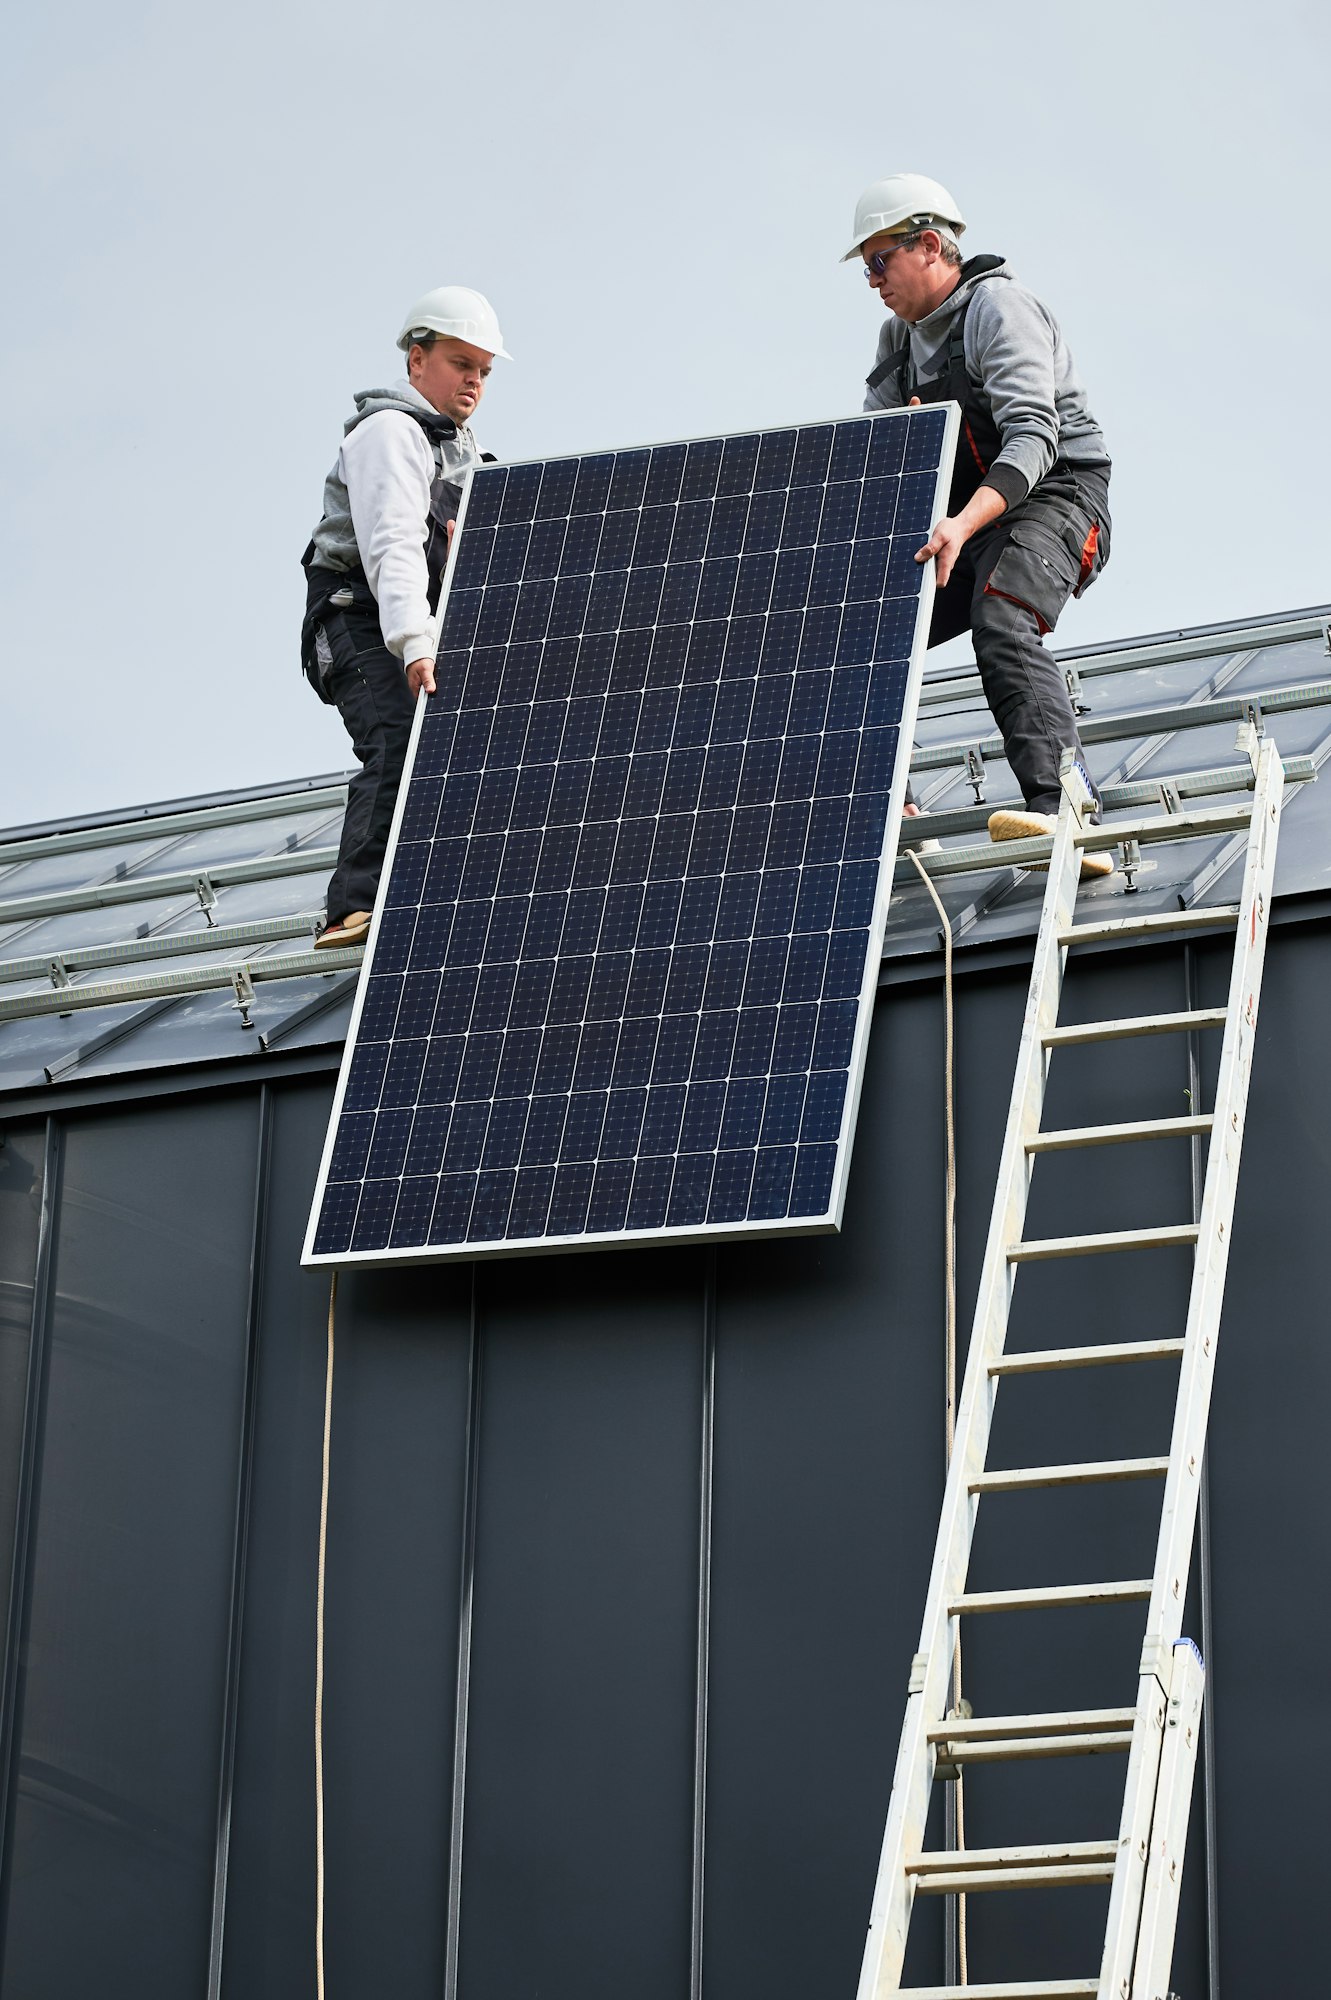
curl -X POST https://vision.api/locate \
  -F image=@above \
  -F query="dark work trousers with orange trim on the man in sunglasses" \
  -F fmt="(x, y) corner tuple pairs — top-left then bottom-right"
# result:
(929, 470), (1109, 812)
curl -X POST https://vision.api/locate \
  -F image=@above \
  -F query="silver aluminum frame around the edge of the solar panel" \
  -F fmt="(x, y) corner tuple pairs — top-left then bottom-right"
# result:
(300, 402), (961, 1268)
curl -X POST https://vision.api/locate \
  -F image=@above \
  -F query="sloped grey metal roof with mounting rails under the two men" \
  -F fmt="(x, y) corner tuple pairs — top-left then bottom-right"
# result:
(0, 606), (1331, 1094)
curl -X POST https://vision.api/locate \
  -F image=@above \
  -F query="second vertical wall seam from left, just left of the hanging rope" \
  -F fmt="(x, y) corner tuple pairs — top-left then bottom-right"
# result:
(208, 1084), (272, 2000)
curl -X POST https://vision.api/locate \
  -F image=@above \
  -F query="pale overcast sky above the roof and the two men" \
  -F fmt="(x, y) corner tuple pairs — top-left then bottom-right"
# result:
(0, 0), (1331, 824)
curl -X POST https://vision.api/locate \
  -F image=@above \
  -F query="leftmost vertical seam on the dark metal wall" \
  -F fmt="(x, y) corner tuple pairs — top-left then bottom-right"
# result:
(0, 1118), (64, 1982)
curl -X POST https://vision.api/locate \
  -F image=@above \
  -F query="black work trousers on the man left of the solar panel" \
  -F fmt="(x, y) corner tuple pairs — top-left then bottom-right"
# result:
(322, 608), (414, 924)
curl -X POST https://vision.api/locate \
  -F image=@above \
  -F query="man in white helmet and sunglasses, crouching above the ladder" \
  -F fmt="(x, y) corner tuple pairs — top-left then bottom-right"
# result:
(843, 174), (1113, 874)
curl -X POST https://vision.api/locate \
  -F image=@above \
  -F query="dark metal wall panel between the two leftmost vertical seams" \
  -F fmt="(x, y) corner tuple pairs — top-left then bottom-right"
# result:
(4, 1098), (258, 2000)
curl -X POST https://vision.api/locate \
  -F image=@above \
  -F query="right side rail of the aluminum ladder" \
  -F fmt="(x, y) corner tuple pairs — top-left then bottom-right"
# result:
(1099, 738), (1285, 2000)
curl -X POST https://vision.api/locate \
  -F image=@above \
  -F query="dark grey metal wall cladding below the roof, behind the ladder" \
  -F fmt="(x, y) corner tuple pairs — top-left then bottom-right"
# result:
(0, 926), (1331, 2000)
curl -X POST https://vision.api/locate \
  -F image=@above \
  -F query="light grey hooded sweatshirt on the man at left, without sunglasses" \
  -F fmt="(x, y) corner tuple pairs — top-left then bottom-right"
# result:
(314, 382), (480, 662)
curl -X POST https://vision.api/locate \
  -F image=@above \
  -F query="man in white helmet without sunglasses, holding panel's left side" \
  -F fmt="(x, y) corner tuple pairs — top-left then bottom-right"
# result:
(300, 284), (510, 946)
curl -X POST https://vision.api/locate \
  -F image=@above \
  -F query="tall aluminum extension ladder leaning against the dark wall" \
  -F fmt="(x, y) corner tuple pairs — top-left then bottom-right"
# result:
(857, 724), (1285, 2000)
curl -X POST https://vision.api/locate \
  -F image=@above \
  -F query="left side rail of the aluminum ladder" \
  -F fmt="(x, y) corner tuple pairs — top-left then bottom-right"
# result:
(855, 798), (1083, 2000)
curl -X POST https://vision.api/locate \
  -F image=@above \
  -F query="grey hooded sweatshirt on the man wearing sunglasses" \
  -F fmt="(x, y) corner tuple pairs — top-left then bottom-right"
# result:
(863, 264), (1109, 506)
